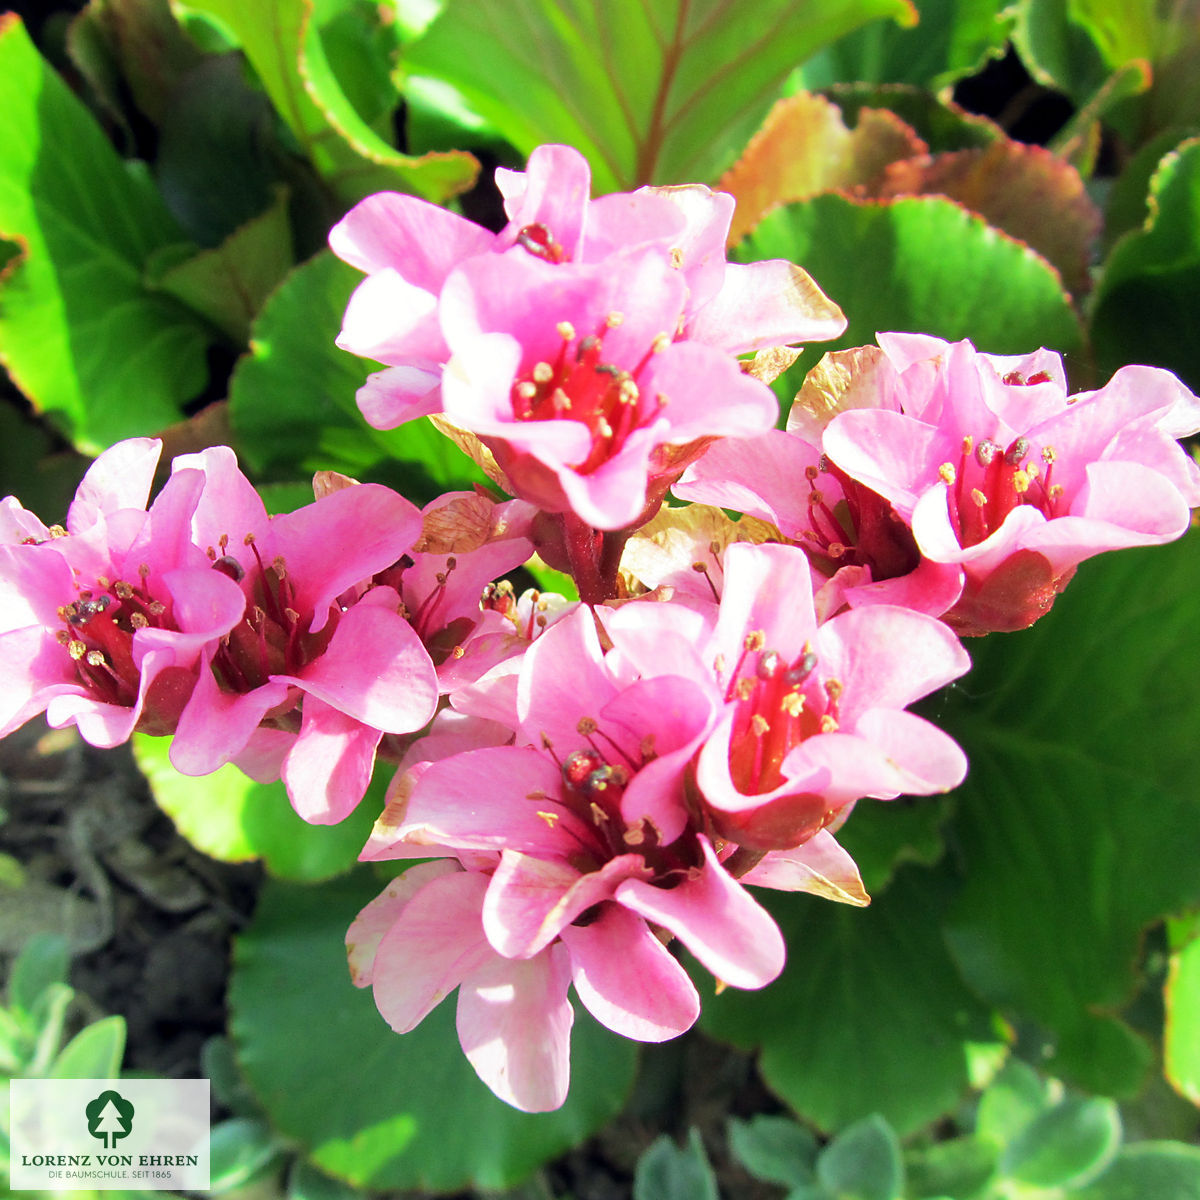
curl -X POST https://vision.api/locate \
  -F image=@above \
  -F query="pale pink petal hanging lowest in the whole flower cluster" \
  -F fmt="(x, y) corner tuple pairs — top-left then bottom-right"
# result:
(457, 946), (575, 1112)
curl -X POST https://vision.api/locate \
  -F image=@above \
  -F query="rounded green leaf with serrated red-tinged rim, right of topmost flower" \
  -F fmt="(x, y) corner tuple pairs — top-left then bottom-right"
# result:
(737, 194), (1080, 354)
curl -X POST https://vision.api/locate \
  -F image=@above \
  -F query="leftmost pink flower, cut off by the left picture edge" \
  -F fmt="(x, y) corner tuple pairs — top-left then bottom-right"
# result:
(0, 438), (245, 746)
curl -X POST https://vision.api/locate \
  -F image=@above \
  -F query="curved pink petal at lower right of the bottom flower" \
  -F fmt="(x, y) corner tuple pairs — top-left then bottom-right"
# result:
(616, 836), (786, 988)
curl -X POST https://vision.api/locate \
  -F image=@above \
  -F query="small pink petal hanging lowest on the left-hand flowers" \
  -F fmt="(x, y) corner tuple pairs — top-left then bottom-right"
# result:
(282, 696), (383, 824)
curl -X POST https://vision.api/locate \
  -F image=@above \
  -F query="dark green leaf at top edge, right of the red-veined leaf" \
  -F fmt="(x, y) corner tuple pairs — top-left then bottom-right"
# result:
(800, 0), (1013, 91)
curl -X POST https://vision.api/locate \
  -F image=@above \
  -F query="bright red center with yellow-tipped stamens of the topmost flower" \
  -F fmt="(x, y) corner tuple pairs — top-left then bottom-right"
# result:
(512, 312), (670, 474)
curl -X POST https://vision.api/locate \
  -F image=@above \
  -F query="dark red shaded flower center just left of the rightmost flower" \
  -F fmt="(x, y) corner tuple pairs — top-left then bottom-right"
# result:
(799, 455), (920, 582)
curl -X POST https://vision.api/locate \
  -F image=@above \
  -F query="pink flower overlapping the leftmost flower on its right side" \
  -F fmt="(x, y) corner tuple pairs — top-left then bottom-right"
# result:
(160, 446), (438, 823)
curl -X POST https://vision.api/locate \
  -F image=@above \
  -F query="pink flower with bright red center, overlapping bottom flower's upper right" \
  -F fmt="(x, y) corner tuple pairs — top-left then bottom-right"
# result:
(605, 542), (970, 851)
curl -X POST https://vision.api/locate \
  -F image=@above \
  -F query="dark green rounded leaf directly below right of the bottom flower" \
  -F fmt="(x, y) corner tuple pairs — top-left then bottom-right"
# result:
(701, 864), (997, 1133)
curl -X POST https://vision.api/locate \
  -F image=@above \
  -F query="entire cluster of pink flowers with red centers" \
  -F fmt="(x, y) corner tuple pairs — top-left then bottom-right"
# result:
(0, 146), (1200, 1111)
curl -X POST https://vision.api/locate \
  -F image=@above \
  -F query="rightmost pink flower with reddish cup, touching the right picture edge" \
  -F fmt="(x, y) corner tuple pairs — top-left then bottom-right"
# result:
(823, 334), (1200, 635)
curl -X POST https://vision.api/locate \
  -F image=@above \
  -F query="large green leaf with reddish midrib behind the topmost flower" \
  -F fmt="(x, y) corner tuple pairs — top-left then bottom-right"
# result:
(406, 0), (912, 192)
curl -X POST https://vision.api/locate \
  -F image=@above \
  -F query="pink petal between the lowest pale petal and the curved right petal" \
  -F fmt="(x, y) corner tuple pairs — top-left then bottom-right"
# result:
(559, 904), (700, 1042)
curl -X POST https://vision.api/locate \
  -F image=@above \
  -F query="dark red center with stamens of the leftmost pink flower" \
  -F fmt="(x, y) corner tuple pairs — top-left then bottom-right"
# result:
(55, 565), (174, 708)
